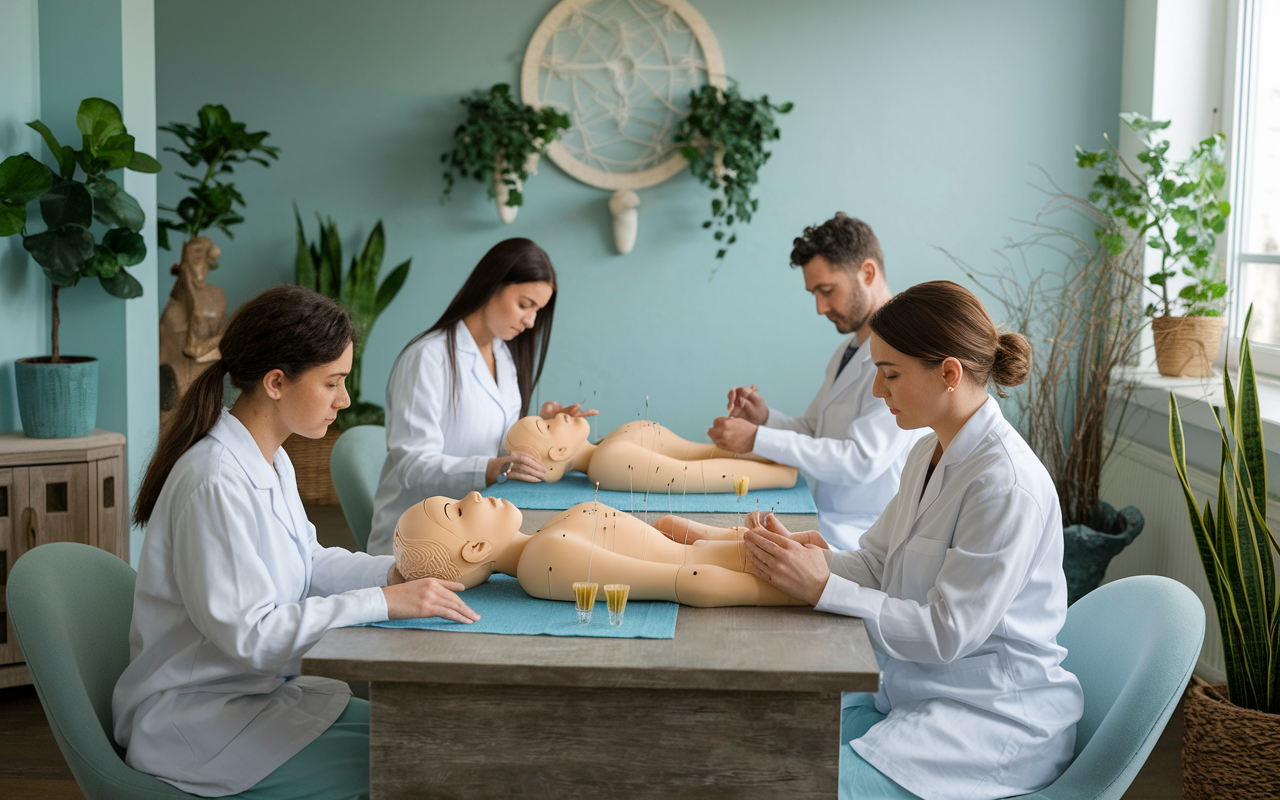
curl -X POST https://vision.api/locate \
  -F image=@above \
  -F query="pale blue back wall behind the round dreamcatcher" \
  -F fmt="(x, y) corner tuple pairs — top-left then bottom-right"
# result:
(154, 0), (1124, 435)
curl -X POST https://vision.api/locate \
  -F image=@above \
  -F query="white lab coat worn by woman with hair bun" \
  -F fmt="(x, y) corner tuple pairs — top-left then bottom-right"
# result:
(815, 397), (1084, 800)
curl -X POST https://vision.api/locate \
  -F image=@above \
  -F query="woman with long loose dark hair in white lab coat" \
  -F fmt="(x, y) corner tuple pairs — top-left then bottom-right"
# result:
(366, 239), (596, 556)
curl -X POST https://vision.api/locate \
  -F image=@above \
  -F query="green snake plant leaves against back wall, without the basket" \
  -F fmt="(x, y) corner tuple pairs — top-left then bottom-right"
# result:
(293, 207), (412, 430)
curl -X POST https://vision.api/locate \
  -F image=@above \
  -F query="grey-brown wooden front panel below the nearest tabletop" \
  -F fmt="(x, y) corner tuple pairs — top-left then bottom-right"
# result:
(370, 682), (840, 800)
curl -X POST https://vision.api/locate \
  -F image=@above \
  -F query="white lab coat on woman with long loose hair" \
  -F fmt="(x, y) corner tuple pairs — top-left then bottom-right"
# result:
(366, 323), (520, 556)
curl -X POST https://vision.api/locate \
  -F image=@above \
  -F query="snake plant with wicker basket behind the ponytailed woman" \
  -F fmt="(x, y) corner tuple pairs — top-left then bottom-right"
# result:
(284, 207), (412, 506)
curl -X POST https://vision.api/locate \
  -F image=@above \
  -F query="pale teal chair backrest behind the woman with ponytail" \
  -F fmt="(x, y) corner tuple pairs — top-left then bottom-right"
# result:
(6, 541), (189, 800)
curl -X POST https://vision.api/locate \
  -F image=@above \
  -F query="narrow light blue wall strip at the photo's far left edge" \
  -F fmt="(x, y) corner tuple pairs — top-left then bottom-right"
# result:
(0, 0), (50, 430)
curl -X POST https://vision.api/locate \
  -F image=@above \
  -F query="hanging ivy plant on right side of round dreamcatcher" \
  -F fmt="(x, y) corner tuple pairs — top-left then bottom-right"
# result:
(675, 81), (794, 259)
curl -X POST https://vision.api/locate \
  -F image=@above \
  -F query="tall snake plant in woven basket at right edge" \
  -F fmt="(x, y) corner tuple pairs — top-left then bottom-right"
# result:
(1169, 307), (1280, 800)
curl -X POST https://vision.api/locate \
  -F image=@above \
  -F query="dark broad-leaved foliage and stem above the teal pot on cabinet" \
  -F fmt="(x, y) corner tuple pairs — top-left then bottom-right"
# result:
(0, 97), (160, 362)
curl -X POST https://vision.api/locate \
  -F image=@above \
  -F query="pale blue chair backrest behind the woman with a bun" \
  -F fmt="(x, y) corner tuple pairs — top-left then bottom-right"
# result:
(1025, 575), (1204, 800)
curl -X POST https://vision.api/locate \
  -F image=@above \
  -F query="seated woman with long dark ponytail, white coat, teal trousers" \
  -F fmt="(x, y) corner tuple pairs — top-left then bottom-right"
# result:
(111, 287), (479, 800)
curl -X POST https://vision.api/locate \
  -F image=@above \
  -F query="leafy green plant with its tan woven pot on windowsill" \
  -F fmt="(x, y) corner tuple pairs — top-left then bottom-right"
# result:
(1075, 114), (1231, 378)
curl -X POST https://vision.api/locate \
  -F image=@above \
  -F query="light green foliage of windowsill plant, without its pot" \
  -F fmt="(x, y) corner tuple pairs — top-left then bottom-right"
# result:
(1075, 114), (1231, 316)
